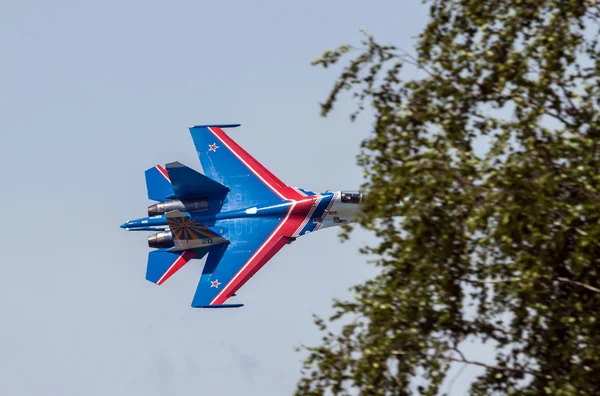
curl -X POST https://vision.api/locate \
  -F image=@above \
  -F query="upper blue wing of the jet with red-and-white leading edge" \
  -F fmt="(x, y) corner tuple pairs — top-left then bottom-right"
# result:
(190, 124), (307, 206)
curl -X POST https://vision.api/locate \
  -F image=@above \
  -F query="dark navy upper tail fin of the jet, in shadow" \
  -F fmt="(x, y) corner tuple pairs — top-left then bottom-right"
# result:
(166, 162), (229, 199)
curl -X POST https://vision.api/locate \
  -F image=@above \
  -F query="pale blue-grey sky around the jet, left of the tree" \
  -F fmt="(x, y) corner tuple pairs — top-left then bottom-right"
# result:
(0, 0), (488, 396)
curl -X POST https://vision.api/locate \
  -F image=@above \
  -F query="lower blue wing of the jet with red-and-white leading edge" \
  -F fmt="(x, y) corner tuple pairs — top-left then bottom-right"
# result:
(192, 204), (304, 308)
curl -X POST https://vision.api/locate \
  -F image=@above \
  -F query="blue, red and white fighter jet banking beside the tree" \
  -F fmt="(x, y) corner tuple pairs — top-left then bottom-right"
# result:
(121, 124), (365, 308)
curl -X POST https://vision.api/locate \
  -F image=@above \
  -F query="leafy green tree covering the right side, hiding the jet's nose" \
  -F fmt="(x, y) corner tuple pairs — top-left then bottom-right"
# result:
(297, 0), (600, 395)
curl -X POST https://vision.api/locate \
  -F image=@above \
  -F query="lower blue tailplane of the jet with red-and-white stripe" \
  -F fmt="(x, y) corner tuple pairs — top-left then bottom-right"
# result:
(146, 248), (209, 285)
